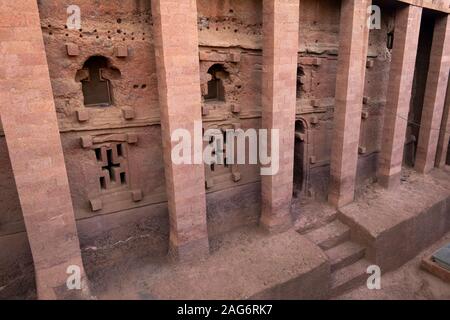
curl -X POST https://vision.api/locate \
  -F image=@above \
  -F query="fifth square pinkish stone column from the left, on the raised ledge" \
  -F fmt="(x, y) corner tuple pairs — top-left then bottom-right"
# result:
(378, 5), (422, 188)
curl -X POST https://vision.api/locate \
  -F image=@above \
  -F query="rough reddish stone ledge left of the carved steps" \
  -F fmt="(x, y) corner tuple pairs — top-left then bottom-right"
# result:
(150, 230), (329, 299)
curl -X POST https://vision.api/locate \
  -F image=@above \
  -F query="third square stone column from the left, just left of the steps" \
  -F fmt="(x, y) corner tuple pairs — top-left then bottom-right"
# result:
(261, 0), (299, 232)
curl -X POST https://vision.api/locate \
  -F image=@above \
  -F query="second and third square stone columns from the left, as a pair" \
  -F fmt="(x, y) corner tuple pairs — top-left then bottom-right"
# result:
(152, 0), (299, 252)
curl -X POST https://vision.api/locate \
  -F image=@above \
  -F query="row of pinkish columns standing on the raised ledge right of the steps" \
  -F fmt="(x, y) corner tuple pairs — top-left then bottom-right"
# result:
(338, 0), (450, 207)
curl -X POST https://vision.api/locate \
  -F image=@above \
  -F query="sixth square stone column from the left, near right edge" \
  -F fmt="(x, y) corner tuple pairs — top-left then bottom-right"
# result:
(415, 15), (450, 173)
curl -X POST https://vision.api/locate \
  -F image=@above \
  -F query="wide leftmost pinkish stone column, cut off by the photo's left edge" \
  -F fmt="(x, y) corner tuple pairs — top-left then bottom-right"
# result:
(0, 0), (88, 299)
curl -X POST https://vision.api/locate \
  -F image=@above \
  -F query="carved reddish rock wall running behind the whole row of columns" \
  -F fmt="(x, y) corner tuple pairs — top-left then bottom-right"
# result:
(0, 0), (426, 298)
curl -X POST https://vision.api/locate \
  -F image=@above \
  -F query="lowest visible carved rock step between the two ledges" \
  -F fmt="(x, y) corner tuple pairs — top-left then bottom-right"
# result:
(331, 259), (370, 297)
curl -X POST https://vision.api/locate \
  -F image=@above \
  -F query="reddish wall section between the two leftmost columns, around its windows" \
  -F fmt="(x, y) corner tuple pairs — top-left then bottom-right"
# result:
(34, 0), (168, 273)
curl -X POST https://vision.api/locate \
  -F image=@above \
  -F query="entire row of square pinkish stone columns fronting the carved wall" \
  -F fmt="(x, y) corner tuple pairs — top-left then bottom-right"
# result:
(0, 0), (449, 298)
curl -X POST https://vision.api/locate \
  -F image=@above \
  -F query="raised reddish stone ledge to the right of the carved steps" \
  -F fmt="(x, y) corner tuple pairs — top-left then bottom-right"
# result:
(339, 169), (450, 272)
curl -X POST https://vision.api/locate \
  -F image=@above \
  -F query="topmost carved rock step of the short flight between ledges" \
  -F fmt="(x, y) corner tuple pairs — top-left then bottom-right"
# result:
(306, 220), (350, 250)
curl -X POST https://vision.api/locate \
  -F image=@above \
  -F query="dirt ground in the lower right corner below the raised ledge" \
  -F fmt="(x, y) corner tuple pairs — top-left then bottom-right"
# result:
(337, 233), (450, 300)
